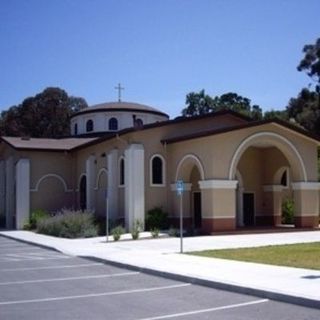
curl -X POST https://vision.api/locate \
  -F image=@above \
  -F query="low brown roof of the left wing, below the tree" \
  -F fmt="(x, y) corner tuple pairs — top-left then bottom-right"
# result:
(0, 137), (97, 151)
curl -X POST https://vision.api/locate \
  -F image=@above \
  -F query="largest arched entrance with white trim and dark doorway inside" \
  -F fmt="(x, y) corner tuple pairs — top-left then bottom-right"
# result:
(229, 132), (307, 227)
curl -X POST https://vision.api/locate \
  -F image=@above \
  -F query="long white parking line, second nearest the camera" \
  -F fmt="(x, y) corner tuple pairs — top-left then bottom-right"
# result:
(0, 283), (191, 306)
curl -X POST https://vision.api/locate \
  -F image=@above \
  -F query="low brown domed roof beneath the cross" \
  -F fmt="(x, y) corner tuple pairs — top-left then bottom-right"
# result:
(71, 101), (169, 118)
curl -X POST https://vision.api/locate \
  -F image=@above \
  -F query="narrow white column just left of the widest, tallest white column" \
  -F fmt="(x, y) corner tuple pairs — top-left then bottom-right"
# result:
(107, 149), (119, 220)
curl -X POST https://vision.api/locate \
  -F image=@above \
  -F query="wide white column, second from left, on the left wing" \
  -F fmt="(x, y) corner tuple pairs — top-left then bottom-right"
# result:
(16, 159), (30, 229)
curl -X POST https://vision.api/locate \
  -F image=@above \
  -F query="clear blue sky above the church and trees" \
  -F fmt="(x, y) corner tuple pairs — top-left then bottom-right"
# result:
(0, 0), (320, 117)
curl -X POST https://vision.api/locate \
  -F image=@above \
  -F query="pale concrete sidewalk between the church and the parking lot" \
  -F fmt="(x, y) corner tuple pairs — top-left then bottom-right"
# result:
(0, 231), (320, 309)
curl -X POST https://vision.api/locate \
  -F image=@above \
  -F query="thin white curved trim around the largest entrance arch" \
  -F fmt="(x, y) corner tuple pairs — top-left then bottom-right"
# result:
(229, 131), (307, 182)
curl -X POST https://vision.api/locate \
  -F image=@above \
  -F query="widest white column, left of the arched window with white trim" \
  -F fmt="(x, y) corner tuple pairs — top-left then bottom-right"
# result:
(125, 144), (145, 230)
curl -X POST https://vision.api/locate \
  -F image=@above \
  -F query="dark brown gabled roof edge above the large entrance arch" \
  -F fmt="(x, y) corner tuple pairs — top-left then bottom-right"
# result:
(161, 118), (320, 144)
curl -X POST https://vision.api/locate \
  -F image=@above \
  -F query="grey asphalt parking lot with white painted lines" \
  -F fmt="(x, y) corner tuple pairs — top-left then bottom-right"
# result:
(0, 237), (320, 320)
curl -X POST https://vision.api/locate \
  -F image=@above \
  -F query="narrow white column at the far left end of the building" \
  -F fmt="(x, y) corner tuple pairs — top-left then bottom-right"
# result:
(6, 157), (15, 229)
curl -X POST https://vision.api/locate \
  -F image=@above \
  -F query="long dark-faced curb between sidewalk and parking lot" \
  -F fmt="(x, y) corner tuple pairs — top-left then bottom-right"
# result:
(0, 234), (320, 309)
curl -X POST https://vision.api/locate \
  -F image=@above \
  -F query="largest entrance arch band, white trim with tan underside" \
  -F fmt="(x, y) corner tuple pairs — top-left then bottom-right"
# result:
(229, 132), (307, 182)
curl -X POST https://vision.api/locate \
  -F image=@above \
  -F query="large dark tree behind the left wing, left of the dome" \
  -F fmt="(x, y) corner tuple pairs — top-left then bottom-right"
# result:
(0, 87), (88, 138)
